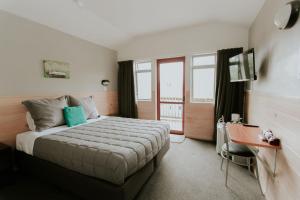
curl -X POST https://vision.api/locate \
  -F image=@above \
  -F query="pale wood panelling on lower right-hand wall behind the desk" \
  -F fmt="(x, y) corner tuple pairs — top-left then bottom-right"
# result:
(247, 92), (300, 200)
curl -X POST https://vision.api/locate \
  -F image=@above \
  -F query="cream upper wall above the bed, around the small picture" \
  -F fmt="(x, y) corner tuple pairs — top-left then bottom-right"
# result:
(0, 11), (117, 96)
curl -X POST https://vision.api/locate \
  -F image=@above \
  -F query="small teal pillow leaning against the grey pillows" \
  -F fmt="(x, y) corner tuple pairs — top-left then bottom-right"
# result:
(64, 106), (86, 127)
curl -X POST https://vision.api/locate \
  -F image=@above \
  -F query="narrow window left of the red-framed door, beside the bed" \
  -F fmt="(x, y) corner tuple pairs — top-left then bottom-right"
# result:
(135, 62), (152, 101)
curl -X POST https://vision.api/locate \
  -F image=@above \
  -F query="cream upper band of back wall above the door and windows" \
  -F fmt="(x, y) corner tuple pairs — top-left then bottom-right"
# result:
(118, 23), (248, 60)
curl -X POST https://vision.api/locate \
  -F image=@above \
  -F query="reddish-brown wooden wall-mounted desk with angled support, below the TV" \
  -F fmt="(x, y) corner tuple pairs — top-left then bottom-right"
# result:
(226, 123), (281, 177)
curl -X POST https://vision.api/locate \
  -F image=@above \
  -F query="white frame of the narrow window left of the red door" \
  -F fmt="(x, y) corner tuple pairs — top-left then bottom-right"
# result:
(134, 61), (153, 101)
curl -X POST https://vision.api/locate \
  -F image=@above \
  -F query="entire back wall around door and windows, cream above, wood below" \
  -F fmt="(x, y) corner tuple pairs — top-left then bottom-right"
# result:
(118, 23), (248, 140)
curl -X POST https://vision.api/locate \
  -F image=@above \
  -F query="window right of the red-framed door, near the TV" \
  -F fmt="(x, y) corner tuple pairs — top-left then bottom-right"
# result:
(191, 54), (216, 102)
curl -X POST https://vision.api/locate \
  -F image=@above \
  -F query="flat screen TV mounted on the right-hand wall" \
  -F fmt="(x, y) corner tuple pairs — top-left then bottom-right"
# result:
(229, 49), (257, 82)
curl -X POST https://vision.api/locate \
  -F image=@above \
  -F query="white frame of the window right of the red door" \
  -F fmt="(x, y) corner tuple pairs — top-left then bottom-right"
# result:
(190, 53), (217, 104)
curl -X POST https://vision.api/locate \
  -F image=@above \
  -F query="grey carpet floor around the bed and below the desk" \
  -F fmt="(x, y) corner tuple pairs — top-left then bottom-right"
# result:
(0, 139), (264, 200)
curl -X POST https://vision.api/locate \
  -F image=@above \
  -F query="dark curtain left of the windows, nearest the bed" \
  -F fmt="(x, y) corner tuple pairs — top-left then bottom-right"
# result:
(118, 60), (136, 118)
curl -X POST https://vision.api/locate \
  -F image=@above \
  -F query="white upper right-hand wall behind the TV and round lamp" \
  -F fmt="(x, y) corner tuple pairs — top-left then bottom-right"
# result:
(249, 0), (300, 97)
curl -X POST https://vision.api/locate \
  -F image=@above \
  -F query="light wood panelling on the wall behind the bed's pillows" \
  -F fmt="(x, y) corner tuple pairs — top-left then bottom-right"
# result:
(0, 91), (118, 146)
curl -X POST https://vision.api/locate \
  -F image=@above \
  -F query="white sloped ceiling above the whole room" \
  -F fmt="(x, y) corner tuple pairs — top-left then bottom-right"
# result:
(0, 0), (264, 49)
